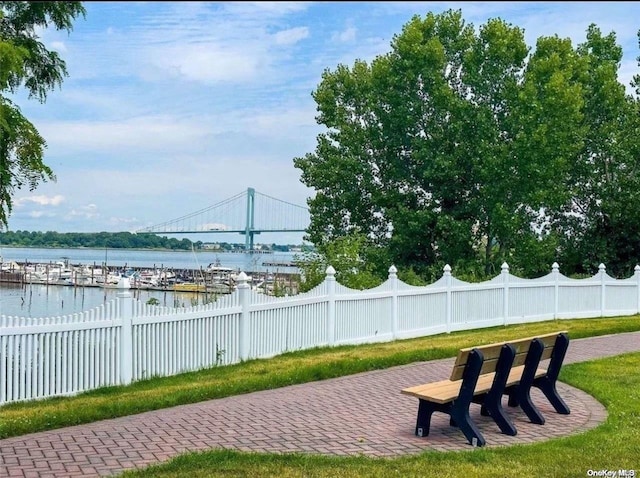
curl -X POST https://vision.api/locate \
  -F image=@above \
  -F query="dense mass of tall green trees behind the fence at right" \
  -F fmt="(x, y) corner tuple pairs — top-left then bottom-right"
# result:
(294, 10), (640, 278)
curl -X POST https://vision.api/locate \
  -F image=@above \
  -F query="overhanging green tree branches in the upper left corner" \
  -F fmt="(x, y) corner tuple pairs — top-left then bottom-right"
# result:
(0, 2), (86, 228)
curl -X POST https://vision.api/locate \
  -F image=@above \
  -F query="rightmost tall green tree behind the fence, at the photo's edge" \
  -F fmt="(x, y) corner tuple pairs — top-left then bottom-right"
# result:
(555, 25), (640, 276)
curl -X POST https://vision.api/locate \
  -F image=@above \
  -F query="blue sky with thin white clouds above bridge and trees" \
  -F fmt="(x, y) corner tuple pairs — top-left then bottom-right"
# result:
(9, 2), (640, 243)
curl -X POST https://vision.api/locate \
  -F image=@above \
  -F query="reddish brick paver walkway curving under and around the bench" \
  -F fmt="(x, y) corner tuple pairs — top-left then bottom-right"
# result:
(0, 332), (640, 478)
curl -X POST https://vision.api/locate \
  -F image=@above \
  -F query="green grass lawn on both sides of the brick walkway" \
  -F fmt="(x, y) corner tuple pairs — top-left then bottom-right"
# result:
(0, 316), (640, 477)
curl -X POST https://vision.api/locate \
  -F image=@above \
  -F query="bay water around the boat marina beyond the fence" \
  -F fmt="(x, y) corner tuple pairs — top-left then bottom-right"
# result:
(0, 247), (299, 317)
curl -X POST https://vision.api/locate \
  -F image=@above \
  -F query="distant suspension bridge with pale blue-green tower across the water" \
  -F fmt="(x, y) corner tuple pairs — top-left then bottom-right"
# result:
(136, 188), (310, 251)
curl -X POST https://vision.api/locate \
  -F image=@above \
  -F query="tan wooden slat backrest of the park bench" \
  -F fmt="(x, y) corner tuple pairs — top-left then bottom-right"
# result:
(449, 331), (567, 381)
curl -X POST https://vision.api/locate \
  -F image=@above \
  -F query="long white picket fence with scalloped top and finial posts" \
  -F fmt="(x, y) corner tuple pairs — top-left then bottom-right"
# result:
(0, 264), (640, 405)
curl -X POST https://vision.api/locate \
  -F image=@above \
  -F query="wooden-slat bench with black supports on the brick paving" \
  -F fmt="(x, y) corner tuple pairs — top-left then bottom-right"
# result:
(401, 331), (570, 446)
